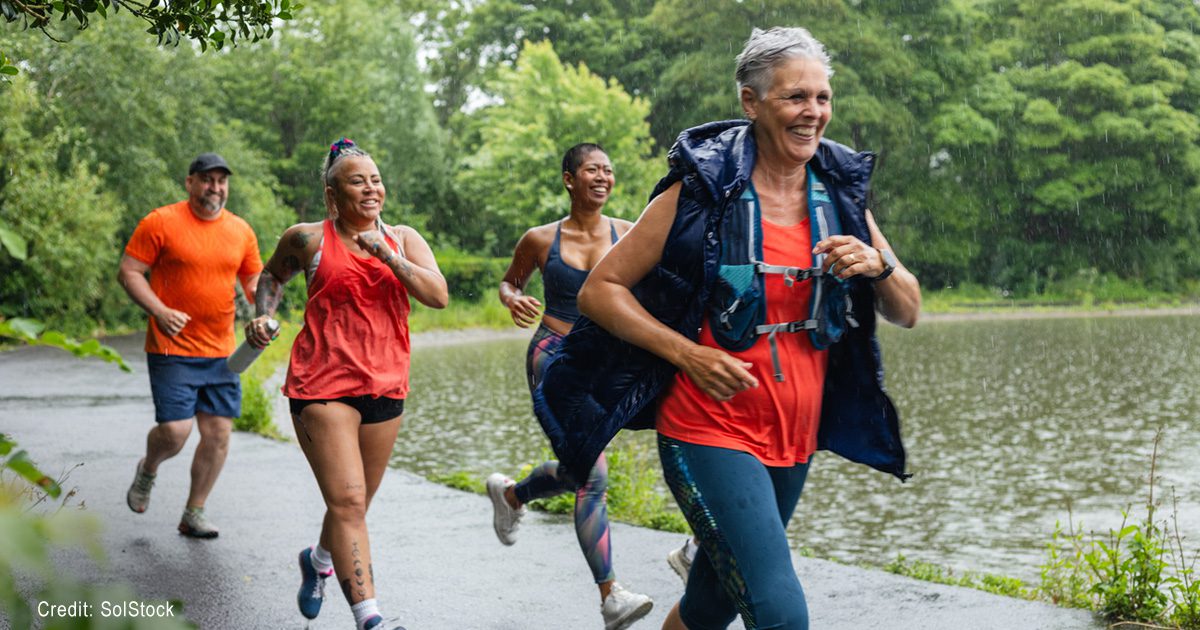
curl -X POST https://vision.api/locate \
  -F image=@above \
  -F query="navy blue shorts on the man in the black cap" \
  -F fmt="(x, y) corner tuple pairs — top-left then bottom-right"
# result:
(146, 354), (241, 422)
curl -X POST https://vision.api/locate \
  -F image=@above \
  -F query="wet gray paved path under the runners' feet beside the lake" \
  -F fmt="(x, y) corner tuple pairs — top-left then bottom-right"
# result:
(0, 337), (1103, 630)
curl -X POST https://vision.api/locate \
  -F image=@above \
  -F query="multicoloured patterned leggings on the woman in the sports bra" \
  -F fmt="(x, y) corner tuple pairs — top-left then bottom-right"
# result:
(514, 325), (614, 584)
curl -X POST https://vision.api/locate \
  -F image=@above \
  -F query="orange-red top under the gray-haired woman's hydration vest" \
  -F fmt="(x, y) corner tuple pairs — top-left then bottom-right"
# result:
(658, 217), (828, 467)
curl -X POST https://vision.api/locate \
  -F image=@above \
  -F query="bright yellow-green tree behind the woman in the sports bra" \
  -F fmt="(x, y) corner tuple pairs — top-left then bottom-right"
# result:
(456, 42), (665, 256)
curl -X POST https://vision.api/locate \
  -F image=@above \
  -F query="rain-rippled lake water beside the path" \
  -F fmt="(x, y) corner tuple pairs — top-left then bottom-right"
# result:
(394, 316), (1200, 582)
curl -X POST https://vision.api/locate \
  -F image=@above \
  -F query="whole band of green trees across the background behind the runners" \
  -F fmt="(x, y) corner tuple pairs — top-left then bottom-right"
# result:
(0, 0), (1200, 332)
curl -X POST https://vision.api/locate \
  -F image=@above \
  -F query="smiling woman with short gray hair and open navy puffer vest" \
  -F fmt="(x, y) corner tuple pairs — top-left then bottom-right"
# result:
(538, 28), (920, 630)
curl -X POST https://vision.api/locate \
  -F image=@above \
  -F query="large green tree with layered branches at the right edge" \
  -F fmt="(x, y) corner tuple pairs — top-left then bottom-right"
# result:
(934, 0), (1200, 292)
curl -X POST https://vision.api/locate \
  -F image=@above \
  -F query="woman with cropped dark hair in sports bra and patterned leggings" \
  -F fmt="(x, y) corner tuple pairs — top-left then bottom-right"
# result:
(487, 143), (653, 630)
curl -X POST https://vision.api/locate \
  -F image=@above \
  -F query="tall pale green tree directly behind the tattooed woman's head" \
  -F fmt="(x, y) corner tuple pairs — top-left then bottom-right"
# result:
(213, 0), (448, 224)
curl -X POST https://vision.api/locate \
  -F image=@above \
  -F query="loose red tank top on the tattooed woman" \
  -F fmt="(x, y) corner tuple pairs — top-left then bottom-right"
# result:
(283, 220), (410, 400)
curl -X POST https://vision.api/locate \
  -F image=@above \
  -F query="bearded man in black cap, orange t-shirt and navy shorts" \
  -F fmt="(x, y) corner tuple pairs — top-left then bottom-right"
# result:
(118, 154), (263, 538)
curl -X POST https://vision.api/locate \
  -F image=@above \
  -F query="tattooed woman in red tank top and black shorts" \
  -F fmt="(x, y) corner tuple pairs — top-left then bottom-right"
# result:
(246, 138), (449, 630)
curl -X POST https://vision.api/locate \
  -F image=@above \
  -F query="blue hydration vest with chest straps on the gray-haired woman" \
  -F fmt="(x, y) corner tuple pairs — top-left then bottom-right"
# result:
(707, 168), (858, 382)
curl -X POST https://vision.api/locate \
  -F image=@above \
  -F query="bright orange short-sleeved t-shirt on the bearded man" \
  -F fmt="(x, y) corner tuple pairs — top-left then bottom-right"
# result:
(125, 200), (263, 358)
